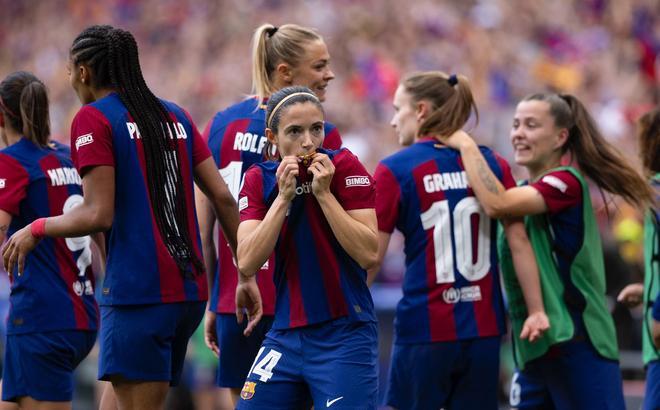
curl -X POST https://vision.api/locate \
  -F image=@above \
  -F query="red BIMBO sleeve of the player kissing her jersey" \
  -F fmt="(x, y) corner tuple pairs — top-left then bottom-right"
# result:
(332, 149), (376, 211)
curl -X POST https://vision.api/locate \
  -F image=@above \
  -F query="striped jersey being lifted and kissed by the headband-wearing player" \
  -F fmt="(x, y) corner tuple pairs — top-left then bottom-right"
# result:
(239, 149), (375, 329)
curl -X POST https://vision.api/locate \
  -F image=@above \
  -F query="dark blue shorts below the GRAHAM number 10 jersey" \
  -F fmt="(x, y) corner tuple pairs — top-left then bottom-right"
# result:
(385, 337), (500, 410)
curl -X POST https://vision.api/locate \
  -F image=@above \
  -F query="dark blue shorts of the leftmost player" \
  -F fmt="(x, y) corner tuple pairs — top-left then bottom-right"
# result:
(2, 330), (96, 401)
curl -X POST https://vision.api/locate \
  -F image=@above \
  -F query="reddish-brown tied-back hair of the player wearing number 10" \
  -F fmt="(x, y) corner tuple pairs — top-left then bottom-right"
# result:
(401, 71), (479, 137)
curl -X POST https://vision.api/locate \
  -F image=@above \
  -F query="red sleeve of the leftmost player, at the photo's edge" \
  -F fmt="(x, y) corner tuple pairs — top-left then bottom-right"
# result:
(0, 153), (30, 215)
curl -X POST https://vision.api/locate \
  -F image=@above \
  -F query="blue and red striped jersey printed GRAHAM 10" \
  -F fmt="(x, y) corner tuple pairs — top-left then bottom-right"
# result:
(374, 138), (515, 344)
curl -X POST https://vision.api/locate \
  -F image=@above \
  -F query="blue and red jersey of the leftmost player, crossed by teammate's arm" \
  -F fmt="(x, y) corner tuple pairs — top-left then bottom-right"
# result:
(0, 138), (98, 334)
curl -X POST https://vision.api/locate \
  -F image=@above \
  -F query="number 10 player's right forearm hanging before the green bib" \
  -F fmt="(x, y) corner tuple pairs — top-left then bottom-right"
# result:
(505, 221), (545, 314)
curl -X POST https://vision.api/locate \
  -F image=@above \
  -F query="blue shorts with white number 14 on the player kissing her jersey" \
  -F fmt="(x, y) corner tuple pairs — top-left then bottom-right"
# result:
(236, 318), (378, 410)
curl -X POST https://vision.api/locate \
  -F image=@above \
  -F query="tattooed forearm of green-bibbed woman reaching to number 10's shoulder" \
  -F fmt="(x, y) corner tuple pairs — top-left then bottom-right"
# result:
(461, 140), (506, 218)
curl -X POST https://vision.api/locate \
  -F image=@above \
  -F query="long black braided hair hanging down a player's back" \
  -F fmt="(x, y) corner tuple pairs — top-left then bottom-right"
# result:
(70, 25), (204, 277)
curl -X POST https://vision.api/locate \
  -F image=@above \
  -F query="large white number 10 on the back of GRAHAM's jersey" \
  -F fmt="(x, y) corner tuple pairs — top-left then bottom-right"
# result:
(420, 196), (490, 283)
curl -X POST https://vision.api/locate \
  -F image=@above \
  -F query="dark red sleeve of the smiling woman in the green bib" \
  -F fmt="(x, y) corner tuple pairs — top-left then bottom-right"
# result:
(531, 171), (582, 214)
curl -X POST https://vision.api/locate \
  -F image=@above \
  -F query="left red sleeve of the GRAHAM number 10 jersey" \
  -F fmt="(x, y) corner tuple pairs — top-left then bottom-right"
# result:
(374, 163), (401, 233)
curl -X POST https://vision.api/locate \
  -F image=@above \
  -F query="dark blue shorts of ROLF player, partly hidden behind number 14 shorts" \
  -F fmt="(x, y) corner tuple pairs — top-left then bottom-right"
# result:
(215, 313), (273, 388)
